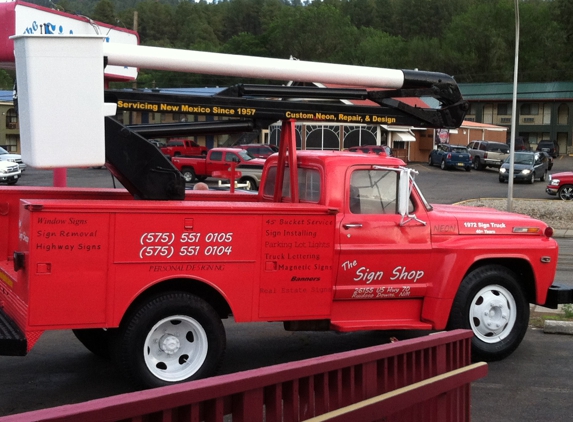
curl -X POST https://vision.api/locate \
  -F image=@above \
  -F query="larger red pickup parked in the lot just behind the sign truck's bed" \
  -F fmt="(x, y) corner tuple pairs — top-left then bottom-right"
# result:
(171, 148), (265, 183)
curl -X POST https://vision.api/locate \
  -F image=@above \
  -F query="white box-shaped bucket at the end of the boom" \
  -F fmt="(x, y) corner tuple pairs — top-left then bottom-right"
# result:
(13, 35), (105, 168)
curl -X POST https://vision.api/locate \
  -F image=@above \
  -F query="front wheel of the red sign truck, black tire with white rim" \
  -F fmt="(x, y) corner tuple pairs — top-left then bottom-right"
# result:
(448, 265), (529, 362)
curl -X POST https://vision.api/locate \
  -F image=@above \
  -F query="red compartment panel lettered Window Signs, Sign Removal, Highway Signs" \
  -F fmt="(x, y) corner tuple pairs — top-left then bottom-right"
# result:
(26, 210), (109, 327)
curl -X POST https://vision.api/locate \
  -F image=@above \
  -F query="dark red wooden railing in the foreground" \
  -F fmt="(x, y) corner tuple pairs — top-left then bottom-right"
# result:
(0, 330), (487, 422)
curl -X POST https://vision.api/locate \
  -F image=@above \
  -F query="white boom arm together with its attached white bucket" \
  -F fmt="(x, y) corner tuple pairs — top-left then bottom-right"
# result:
(13, 35), (412, 168)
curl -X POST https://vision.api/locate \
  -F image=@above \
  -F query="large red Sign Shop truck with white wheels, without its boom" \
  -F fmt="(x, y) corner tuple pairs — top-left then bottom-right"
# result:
(0, 143), (558, 387)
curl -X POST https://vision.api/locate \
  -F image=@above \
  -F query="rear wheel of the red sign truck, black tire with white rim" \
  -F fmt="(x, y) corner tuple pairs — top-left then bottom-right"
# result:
(110, 292), (226, 388)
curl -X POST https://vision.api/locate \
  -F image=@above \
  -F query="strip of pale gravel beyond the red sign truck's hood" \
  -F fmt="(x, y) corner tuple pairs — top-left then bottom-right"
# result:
(456, 198), (573, 229)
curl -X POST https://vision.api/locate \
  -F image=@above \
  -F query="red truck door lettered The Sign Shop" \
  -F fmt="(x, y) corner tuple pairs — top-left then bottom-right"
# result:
(334, 167), (432, 300)
